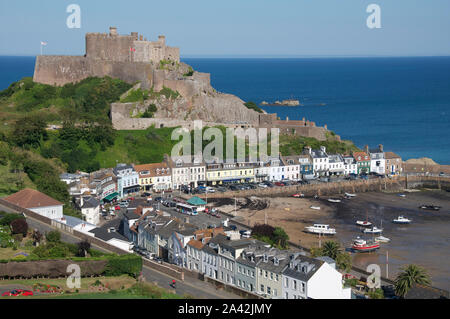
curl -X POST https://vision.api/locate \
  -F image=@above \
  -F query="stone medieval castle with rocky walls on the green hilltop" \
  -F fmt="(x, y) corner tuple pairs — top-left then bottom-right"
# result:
(33, 27), (334, 140)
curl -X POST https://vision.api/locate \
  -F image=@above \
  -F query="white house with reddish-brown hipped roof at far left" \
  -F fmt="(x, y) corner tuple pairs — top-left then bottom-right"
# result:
(4, 188), (64, 220)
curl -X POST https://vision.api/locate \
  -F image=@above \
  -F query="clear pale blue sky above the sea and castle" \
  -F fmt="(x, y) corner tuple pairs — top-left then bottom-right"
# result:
(0, 0), (450, 57)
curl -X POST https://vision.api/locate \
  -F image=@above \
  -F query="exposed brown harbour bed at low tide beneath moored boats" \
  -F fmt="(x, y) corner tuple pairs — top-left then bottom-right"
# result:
(211, 190), (450, 290)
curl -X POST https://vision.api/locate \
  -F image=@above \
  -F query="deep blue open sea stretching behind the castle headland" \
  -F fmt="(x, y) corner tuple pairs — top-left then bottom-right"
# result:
(0, 57), (450, 164)
